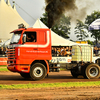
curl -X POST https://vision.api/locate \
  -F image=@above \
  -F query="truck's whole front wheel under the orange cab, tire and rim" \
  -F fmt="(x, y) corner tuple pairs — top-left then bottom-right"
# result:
(30, 63), (46, 81)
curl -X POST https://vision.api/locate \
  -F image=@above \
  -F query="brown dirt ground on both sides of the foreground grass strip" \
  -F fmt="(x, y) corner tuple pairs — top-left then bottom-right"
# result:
(0, 71), (100, 100)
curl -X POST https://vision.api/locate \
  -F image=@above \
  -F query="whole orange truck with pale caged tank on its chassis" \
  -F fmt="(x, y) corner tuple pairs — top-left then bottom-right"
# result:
(7, 24), (100, 80)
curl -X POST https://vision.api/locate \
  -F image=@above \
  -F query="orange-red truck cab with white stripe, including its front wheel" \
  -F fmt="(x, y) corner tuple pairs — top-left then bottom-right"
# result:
(7, 25), (52, 80)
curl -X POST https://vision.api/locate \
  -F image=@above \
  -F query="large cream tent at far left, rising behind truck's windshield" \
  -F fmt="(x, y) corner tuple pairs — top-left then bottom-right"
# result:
(0, 0), (29, 41)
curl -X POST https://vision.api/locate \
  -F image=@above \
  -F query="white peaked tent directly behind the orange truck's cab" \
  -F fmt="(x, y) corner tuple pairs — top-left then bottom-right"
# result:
(33, 19), (77, 46)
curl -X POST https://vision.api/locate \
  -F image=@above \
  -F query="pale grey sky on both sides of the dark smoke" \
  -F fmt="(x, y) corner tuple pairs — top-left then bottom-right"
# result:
(9, 0), (100, 40)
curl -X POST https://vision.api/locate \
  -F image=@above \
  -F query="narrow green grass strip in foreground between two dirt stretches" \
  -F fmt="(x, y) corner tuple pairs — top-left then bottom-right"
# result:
(0, 81), (100, 89)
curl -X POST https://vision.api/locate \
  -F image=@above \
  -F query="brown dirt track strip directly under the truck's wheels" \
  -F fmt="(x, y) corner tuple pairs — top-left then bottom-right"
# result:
(0, 71), (100, 84)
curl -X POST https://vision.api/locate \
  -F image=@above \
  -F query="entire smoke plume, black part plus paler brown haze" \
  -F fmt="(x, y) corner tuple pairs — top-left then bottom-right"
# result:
(45, 0), (94, 28)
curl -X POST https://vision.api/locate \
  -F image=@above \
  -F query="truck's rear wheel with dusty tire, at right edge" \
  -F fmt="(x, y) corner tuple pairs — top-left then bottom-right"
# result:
(83, 64), (100, 79)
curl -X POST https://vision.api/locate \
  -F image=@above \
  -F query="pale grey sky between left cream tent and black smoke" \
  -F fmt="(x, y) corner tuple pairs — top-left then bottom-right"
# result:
(9, 0), (45, 26)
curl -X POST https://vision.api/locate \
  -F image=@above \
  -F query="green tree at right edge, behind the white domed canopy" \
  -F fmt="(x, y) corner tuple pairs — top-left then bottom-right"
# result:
(85, 11), (100, 44)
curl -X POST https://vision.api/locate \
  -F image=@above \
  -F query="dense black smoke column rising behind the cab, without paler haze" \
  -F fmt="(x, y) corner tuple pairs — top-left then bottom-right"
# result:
(45, 0), (76, 28)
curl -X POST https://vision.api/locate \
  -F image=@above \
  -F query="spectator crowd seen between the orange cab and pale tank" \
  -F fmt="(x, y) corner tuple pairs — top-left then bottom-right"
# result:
(52, 46), (72, 57)
